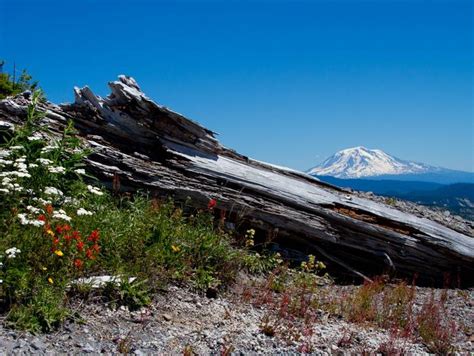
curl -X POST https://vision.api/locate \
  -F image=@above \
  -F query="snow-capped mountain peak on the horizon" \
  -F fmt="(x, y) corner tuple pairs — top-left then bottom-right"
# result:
(307, 147), (441, 178)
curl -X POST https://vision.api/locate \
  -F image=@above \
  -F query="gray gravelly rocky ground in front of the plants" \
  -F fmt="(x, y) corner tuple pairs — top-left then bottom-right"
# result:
(0, 286), (474, 355)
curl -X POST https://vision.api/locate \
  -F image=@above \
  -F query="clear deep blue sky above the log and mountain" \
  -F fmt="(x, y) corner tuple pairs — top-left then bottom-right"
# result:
(0, 0), (474, 171)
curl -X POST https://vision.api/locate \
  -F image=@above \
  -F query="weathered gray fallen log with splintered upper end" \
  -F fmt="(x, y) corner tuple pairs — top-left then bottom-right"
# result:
(0, 76), (474, 286)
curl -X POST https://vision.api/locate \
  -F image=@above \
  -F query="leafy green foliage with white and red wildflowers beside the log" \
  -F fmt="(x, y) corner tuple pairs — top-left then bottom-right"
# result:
(0, 91), (266, 331)
